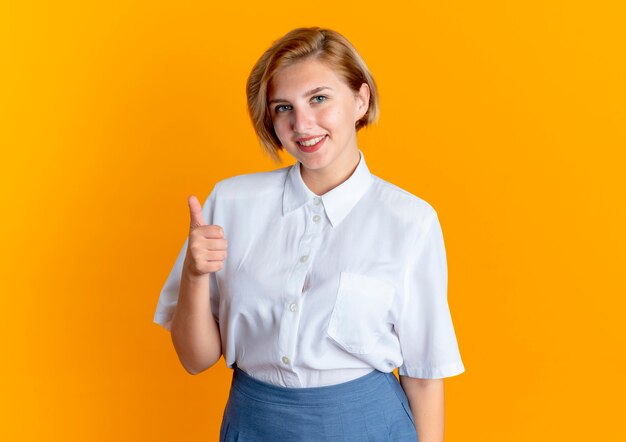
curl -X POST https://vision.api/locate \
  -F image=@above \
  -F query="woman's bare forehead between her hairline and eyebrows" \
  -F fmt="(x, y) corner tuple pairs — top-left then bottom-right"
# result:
(268, 60), (347, 99)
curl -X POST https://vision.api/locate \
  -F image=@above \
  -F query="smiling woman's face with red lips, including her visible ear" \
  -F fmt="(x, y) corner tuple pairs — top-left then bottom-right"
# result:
(268, 59), (369, 177)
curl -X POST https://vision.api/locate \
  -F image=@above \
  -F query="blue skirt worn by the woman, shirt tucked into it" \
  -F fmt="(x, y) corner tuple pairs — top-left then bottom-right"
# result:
(219, 365), (417, 442)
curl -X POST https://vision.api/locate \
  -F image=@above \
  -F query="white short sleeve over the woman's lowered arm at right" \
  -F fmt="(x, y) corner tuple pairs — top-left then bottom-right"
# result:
(395, 210), (465, 379)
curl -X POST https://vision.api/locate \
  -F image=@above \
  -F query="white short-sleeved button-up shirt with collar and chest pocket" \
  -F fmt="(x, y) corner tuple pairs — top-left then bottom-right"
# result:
(154, 150), (465, 387)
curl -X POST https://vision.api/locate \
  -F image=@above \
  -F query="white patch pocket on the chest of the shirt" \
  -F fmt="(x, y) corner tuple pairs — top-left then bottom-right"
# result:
(326, 272), (395, 354)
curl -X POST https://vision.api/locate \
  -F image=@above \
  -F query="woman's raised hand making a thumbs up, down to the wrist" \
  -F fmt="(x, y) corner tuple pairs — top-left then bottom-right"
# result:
(183, 195), (228, 276)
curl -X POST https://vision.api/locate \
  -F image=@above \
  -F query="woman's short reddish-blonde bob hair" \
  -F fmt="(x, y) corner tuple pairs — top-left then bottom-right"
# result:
(246, 26), (378, 163)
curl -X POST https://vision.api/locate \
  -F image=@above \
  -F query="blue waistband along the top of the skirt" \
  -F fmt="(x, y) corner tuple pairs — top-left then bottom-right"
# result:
(232, 364), (395, 406)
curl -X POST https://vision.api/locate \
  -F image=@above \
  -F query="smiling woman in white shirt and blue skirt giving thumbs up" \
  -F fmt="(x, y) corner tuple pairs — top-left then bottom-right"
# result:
(154, 27), (465, 442)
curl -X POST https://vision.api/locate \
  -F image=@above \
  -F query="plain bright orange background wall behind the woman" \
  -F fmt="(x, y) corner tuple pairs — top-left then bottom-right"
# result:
(0, 0), (626, 442)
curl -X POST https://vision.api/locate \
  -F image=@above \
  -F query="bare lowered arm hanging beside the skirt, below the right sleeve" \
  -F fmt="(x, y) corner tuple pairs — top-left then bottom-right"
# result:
(400, 376), (444, 442)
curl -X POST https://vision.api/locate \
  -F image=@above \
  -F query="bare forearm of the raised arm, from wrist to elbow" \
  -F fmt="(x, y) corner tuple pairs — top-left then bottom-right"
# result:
(171, 262), (222, 374)
